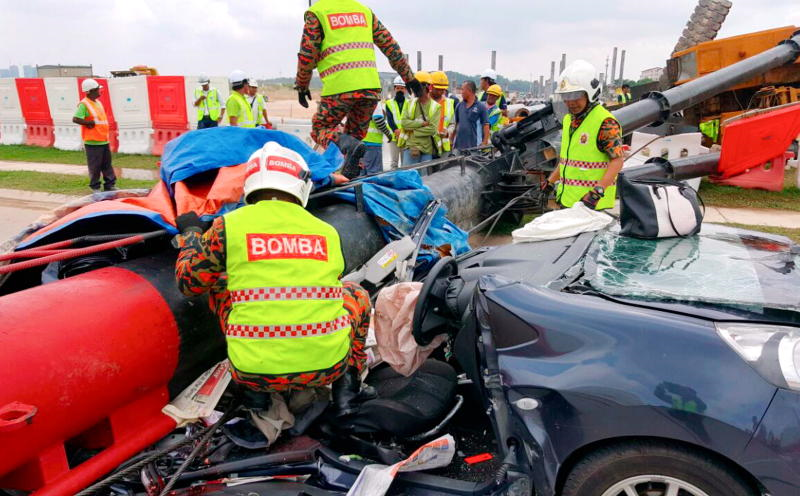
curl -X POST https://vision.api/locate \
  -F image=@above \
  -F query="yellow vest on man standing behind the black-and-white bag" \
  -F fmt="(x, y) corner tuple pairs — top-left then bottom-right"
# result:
(556, 105), (617, 210)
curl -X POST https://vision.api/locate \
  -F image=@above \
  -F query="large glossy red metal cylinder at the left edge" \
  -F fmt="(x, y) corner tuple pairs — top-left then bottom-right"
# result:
(0, 267), (180, 484)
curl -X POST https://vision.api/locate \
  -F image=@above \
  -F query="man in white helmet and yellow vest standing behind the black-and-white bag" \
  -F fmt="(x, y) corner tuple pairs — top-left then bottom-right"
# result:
(542, 60), (624, 210)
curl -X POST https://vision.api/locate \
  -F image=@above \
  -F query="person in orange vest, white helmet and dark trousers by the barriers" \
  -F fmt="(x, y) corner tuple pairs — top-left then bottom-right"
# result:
(72, 79), (117, 193)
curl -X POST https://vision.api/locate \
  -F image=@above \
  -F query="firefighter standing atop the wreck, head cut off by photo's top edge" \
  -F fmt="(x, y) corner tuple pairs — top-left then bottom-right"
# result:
(295, 0), (419, 178)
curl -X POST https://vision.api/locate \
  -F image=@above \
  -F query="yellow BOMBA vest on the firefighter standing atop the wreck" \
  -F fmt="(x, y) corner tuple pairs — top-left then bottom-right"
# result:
(308, 0), (381, 96)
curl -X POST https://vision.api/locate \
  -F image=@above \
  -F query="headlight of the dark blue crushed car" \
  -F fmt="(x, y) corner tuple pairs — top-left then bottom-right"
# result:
(716, 323), (800, 391)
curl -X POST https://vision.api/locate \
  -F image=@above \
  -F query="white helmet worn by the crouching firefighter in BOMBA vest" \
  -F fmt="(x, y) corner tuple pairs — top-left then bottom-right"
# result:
(244, 141), (313, 207)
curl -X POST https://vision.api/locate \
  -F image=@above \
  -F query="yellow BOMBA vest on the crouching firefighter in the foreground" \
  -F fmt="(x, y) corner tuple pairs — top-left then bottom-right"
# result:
(225, 200), (351, 375)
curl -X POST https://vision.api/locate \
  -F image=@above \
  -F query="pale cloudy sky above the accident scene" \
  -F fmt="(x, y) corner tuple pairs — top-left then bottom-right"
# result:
(0, 0), (800, 80)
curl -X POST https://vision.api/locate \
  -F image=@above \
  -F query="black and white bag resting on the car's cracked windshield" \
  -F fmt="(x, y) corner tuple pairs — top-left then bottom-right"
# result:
(617, 174), (705, 239)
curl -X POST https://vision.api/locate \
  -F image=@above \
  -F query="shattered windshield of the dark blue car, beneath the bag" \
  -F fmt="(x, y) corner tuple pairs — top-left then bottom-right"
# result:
(583, 224), (800, 310)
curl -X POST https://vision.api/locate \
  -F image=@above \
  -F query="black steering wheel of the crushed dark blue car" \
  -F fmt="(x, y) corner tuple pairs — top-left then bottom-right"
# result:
(411, 257), (458, 346)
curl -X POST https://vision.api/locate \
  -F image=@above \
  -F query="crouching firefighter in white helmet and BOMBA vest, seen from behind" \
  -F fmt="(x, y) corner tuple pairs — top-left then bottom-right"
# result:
(175, 143), (374, 416)
